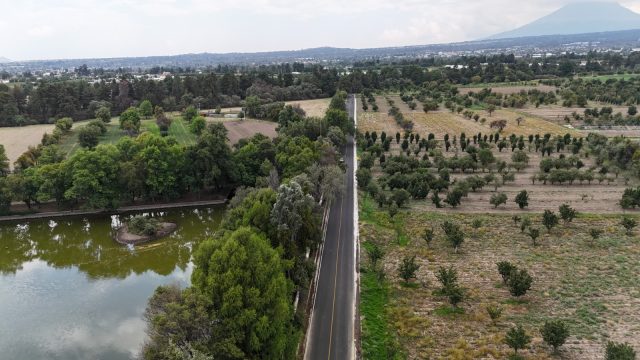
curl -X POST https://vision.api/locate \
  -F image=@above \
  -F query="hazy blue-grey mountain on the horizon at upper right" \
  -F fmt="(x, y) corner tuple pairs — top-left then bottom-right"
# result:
(488, 2), (640, 39)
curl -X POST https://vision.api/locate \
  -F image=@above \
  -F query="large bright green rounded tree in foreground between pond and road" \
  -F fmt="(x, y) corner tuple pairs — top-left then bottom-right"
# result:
(192, 227), (297, 359)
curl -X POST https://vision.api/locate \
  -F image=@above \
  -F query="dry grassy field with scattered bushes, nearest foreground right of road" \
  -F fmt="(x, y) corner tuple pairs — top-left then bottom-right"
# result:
(360, 196), (640, 360)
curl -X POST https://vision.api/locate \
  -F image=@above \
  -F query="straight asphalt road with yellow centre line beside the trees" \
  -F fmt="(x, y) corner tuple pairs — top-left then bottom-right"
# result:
(304, 96), (356, 360)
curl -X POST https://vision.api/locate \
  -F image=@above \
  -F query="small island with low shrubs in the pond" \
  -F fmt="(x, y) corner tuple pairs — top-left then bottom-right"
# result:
(116, 216), (178, 245)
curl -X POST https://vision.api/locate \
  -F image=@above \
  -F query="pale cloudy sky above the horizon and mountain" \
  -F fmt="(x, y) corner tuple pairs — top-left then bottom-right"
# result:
(0, 0), (640, 60)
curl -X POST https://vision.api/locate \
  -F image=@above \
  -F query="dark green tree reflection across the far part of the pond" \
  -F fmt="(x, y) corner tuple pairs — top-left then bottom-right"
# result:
(0, 208), (222, 279)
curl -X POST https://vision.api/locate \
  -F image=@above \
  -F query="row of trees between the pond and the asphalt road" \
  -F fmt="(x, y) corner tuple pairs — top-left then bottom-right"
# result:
(143, 90), (352, 359)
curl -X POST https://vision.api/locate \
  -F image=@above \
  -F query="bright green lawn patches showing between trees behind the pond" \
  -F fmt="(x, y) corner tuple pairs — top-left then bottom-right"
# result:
(60, 117), (197, 156)
